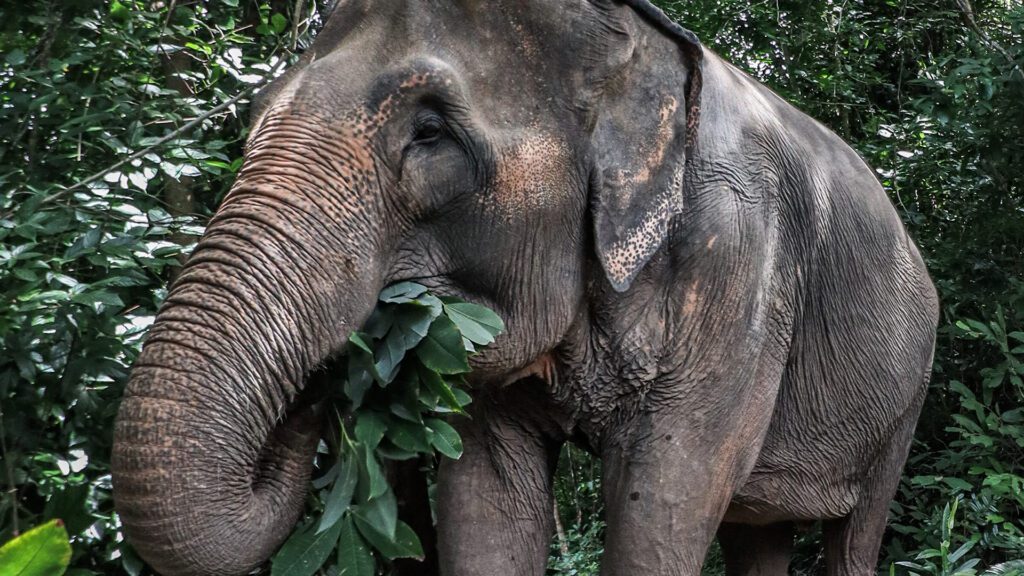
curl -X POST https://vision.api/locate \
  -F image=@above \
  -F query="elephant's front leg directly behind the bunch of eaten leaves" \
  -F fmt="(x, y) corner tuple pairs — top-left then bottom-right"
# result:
(437, 381), (561, 576)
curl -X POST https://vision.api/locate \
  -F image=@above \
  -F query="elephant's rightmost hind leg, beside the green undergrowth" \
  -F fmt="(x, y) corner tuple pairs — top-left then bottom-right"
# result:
(822, 390), (924, 576)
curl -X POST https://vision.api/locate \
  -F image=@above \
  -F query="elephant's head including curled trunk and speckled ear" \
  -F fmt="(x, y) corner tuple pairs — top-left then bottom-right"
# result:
(113, 0), (700, 574)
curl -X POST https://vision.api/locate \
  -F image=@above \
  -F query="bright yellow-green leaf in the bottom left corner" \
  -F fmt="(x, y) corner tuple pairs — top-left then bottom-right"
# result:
(0, 520), (71, 576)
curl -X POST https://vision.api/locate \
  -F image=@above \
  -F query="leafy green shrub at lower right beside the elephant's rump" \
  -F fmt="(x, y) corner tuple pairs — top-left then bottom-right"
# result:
(891, 307), (1024, 562)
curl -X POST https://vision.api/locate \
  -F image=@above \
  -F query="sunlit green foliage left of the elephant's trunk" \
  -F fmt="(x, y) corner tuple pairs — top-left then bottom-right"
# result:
(0, 0), (322, 574)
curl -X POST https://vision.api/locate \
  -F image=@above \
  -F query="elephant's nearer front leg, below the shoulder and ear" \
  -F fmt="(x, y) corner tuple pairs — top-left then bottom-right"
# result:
(601, 407), (766, 576)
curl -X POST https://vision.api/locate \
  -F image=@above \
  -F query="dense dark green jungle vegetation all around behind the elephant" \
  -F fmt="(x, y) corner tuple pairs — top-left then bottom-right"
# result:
(0, 0), (1024, 576)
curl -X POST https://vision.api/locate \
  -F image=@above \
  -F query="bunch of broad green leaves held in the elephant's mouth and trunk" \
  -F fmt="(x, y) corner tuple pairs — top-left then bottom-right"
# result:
(271, 282), (504, 576)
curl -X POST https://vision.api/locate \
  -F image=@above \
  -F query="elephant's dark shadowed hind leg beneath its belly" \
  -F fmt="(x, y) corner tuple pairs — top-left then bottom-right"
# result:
(718, 522), (794, 576)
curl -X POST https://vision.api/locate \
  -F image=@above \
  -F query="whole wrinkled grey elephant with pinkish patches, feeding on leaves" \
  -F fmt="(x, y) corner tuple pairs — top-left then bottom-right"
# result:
(114, 0), (937, 575)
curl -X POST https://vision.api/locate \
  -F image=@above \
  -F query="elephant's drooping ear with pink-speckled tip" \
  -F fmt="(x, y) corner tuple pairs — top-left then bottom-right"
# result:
(588, 0), (702, 292)
